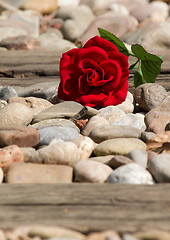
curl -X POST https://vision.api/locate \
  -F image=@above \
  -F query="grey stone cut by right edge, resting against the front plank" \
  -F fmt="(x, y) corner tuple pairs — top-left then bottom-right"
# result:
(148, 154), (170, 183)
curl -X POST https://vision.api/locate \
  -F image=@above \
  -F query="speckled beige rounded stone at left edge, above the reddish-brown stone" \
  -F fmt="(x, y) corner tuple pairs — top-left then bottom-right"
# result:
(0, 103), (33, 128)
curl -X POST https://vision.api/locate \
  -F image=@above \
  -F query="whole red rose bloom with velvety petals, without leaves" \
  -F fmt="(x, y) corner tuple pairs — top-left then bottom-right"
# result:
(58, 36), (129, 107)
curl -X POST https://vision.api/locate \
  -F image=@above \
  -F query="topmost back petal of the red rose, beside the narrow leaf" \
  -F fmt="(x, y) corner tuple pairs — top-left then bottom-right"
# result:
(83, 36), (119, 52)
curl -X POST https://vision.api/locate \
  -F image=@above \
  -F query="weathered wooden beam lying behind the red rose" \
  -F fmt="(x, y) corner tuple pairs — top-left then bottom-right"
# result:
(0, 50), (170, 92)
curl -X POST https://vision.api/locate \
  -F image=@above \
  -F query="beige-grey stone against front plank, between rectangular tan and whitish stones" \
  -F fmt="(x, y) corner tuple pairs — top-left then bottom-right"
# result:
(74, 159), (113, 183)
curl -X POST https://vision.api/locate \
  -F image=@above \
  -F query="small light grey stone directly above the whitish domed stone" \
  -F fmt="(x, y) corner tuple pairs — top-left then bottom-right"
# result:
(126, 149), (148, 168)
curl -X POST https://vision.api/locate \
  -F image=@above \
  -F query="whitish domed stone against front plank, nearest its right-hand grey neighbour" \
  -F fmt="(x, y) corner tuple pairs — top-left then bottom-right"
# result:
(106, 163), (154, 184)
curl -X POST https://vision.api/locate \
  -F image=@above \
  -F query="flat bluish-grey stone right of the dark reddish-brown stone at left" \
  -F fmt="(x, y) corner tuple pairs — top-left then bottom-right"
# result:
(38, 126), (80, 146)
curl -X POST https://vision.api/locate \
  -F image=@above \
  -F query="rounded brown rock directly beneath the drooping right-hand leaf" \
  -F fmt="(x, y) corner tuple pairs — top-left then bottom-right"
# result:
(134, 83), (168, 111)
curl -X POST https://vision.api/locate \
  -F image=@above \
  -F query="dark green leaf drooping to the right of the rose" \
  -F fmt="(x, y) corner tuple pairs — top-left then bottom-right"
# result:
(131, 44), (163, 83)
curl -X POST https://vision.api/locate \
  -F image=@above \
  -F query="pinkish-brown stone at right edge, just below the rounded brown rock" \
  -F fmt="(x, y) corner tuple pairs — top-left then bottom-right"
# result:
(145, 96), (170, 134)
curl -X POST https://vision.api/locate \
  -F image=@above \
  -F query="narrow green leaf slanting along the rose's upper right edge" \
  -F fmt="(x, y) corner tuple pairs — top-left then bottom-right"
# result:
(98, 28), (130, 56)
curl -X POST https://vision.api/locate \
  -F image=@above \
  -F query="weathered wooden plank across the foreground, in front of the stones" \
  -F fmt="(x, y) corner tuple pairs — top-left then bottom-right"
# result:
(0, 183), (170, 233)
